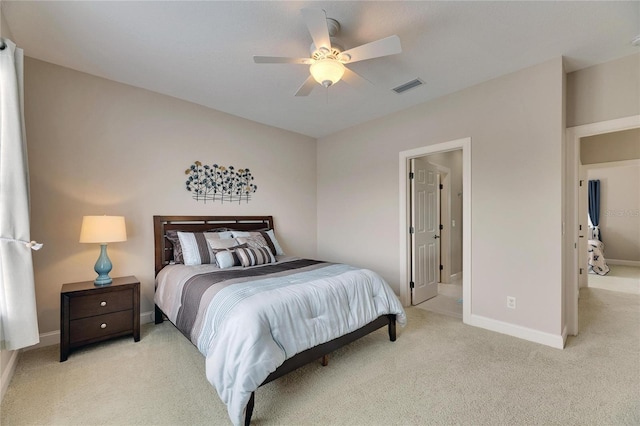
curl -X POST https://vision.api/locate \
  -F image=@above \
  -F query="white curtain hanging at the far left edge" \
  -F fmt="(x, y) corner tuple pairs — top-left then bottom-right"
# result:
(0, 39), (40, 350)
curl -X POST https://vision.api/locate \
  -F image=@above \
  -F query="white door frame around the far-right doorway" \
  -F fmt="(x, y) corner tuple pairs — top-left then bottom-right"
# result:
(563, 115), (640, 336)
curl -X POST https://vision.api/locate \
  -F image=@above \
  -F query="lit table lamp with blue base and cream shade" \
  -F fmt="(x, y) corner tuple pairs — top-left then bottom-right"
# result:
(80, 216), (127, 286)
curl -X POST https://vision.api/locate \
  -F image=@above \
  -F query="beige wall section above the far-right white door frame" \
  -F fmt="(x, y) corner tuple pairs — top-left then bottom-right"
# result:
(567, 53), (640, 127)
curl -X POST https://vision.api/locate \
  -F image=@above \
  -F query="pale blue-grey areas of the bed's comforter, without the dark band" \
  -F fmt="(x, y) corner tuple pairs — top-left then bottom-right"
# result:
(156, 259), (406, 425)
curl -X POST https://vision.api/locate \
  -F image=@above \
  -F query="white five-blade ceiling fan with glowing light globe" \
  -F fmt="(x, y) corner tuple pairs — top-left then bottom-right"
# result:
(253, 9), (402, 96)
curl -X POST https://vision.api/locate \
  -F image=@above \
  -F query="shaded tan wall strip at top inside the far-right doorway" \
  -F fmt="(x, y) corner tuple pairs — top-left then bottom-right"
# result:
(580, 128), (640, 164)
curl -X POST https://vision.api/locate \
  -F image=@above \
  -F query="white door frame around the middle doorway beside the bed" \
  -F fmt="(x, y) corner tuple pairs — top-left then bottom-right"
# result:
(398, 137), (472, 323)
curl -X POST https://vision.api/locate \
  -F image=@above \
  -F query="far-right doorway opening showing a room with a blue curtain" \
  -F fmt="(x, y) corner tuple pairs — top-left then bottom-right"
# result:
(578, 143), (640, 294)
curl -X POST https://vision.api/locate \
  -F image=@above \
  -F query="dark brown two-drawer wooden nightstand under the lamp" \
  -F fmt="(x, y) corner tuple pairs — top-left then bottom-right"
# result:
(60, 276), (140, 362)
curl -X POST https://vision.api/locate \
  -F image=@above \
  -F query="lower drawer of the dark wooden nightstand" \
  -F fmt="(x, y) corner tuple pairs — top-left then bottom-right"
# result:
(69, 310), (133, 346)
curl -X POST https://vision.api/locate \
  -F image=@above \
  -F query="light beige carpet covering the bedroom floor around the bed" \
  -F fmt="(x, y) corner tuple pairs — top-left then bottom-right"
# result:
(0, 288), (640, 426)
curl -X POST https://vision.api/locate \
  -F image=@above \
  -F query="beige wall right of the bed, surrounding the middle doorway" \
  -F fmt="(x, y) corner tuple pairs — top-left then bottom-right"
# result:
(318, 58), (564, 336)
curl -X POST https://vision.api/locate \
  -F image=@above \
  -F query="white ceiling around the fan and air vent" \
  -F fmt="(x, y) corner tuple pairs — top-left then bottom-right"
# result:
(1, 0), (640, 137)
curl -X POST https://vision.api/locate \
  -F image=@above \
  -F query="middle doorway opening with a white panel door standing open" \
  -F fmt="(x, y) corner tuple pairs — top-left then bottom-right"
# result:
(409, 155), (463, 318)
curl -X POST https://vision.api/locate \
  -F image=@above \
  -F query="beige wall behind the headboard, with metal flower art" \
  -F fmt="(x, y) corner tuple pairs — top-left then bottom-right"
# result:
(25, 58), (316, 333)
